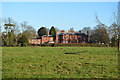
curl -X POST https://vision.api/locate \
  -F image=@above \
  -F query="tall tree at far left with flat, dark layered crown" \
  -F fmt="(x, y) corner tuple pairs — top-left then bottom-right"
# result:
(2, 18), (16, 46)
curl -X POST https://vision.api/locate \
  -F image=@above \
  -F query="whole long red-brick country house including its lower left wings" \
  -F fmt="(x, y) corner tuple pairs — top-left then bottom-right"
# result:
(29, 30), (88, 44)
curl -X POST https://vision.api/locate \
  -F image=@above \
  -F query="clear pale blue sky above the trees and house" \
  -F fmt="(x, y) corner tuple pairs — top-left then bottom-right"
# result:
(2, 2), (118, 31)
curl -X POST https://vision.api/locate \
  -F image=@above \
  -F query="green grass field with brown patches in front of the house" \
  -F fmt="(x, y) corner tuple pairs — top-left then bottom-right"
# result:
(2, 47), (118, 78)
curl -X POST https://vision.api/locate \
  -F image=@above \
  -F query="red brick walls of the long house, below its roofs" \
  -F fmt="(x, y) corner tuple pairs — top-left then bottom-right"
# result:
(29, 34), (88, 44)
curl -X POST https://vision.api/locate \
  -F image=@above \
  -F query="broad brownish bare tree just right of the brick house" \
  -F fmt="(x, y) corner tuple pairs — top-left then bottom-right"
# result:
(91, 16), (109, 44)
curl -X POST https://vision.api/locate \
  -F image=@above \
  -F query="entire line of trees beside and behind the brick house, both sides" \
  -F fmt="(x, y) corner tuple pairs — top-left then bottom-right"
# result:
(1, 16), (120, 47)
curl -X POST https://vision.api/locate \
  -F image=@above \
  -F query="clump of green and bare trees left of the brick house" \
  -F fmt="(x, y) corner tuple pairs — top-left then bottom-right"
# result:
(0, 18), (36, 47)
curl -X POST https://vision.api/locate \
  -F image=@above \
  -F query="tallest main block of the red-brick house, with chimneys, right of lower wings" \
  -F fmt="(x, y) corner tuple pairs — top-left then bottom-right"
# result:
(58, 30), (88, 43)
